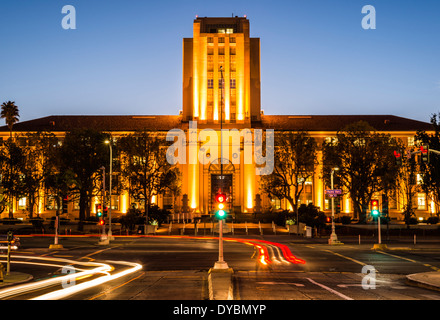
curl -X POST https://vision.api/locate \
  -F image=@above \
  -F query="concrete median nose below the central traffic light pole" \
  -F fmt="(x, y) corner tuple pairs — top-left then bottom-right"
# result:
(208, 268), (234, 300)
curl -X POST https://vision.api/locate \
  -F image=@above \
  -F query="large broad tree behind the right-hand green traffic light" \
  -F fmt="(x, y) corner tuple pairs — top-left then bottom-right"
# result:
(322, 121), (398, 222)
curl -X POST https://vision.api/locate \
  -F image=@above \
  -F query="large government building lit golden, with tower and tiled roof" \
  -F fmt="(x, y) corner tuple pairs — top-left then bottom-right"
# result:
(0, 17), (434, 219)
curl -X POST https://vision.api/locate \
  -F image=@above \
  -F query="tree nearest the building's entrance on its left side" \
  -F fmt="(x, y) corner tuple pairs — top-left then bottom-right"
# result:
(118, 130), (179, 223)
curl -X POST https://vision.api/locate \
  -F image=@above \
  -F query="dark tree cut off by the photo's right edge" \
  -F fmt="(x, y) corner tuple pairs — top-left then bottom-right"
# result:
(415, 113), (440, 214)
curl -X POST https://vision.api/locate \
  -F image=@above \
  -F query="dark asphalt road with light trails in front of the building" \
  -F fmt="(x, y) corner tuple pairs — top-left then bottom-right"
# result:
(2, 235), (440, 301)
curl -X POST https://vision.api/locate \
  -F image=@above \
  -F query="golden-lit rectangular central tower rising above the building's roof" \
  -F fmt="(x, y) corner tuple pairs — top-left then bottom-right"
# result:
(182, 17), (261, 124)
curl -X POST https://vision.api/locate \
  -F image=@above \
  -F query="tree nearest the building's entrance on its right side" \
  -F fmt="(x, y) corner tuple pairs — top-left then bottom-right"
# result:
(260, 131), (317, 218)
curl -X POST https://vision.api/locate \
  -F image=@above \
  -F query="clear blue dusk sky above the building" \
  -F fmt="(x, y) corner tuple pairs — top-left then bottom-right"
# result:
(0, 0), (440, 121)
